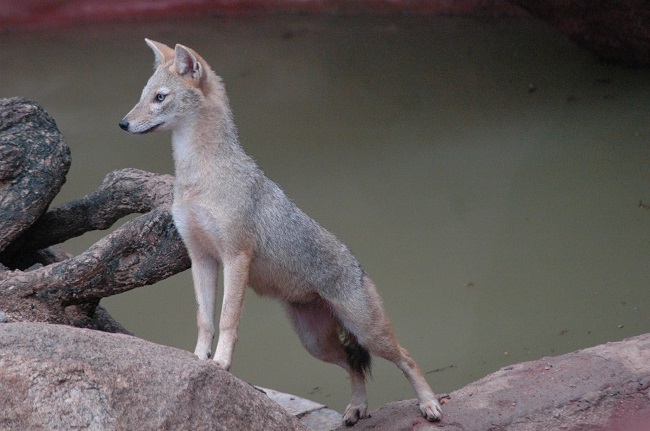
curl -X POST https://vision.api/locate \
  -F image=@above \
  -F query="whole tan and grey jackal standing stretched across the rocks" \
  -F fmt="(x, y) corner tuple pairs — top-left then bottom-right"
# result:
(120, 39), (441, 425)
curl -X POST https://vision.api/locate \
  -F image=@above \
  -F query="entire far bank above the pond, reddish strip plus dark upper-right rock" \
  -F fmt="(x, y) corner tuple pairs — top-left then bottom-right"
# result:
(0, 0), (650, 66)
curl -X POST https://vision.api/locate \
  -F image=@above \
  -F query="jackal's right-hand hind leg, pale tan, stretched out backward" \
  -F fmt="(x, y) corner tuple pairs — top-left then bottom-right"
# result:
(333, 277), (442, 421)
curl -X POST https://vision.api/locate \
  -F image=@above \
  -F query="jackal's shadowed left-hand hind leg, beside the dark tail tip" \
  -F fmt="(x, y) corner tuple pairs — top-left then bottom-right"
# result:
(286, 302), (369, 426)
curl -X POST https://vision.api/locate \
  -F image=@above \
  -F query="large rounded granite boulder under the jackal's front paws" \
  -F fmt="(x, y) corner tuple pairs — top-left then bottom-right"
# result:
(0, 323), (307, 431)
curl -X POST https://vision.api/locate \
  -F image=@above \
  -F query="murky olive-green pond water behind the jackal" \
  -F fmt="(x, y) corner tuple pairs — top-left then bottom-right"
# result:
(0, 17), (650, 411)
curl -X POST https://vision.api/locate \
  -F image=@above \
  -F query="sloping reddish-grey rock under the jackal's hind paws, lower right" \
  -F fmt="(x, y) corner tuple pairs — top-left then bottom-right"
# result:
(339, 334), (650, 431)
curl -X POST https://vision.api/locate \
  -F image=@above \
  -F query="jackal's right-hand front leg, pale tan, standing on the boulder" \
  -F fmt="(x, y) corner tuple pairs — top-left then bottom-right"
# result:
(214, 252), (251, 370)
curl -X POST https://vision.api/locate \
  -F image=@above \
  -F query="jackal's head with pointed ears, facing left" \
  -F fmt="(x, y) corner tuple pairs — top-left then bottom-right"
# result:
(120, 39), (220, 137)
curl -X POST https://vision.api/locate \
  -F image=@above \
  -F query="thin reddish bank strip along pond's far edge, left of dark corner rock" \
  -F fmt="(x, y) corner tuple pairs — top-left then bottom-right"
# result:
(0, 0), (522, 28)
